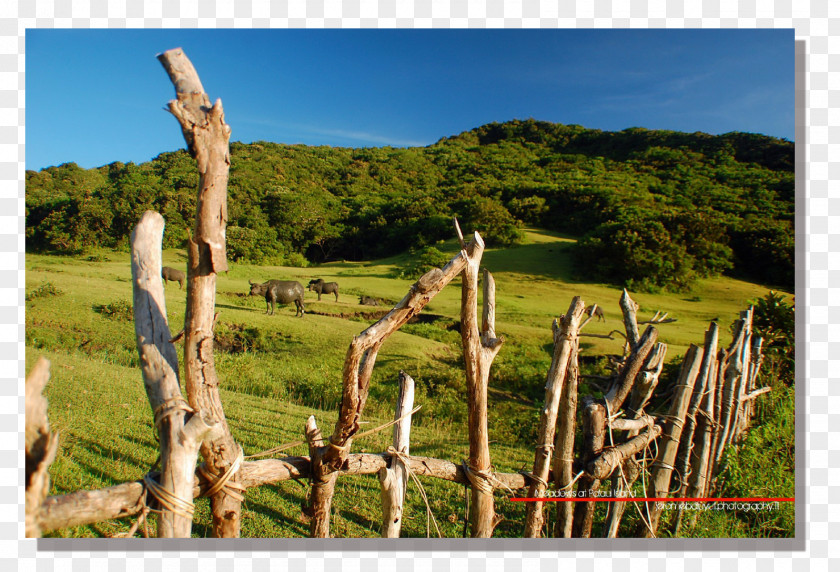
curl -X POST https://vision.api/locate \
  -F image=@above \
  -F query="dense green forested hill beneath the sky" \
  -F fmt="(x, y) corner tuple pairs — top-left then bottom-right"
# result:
(26, 120), (794, 289)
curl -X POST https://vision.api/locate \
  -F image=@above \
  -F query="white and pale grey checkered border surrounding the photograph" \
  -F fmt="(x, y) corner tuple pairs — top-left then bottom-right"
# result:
(0, 0), (840, 572)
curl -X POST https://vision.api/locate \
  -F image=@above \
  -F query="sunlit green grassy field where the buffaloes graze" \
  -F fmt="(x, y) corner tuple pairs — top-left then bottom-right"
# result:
(26, 229), (792, 537)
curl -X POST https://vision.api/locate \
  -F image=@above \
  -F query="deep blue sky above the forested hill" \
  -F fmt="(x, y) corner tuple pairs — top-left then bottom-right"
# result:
(26, 29), (795, 169)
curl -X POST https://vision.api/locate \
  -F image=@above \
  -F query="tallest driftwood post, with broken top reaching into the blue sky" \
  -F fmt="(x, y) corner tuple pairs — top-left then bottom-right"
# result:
(158, 48), (242, 538)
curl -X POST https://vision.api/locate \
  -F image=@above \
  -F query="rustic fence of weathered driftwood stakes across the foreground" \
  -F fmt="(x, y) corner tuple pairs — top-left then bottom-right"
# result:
(21, 50), (769, 538)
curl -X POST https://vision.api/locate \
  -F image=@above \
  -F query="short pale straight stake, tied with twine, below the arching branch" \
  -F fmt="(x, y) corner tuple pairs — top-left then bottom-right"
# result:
(379, 371), (414, 538)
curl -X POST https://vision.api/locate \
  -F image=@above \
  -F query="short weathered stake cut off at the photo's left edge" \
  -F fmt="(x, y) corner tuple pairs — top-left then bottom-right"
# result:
(24, 358), (58, 538)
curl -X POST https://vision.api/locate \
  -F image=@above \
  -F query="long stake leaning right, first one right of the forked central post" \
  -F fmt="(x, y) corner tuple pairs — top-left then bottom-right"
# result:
(524, 296), (585, 538)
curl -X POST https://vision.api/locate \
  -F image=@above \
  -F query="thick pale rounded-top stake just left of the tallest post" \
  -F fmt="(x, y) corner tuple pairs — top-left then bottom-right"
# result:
(131, 211), (216, 538)
